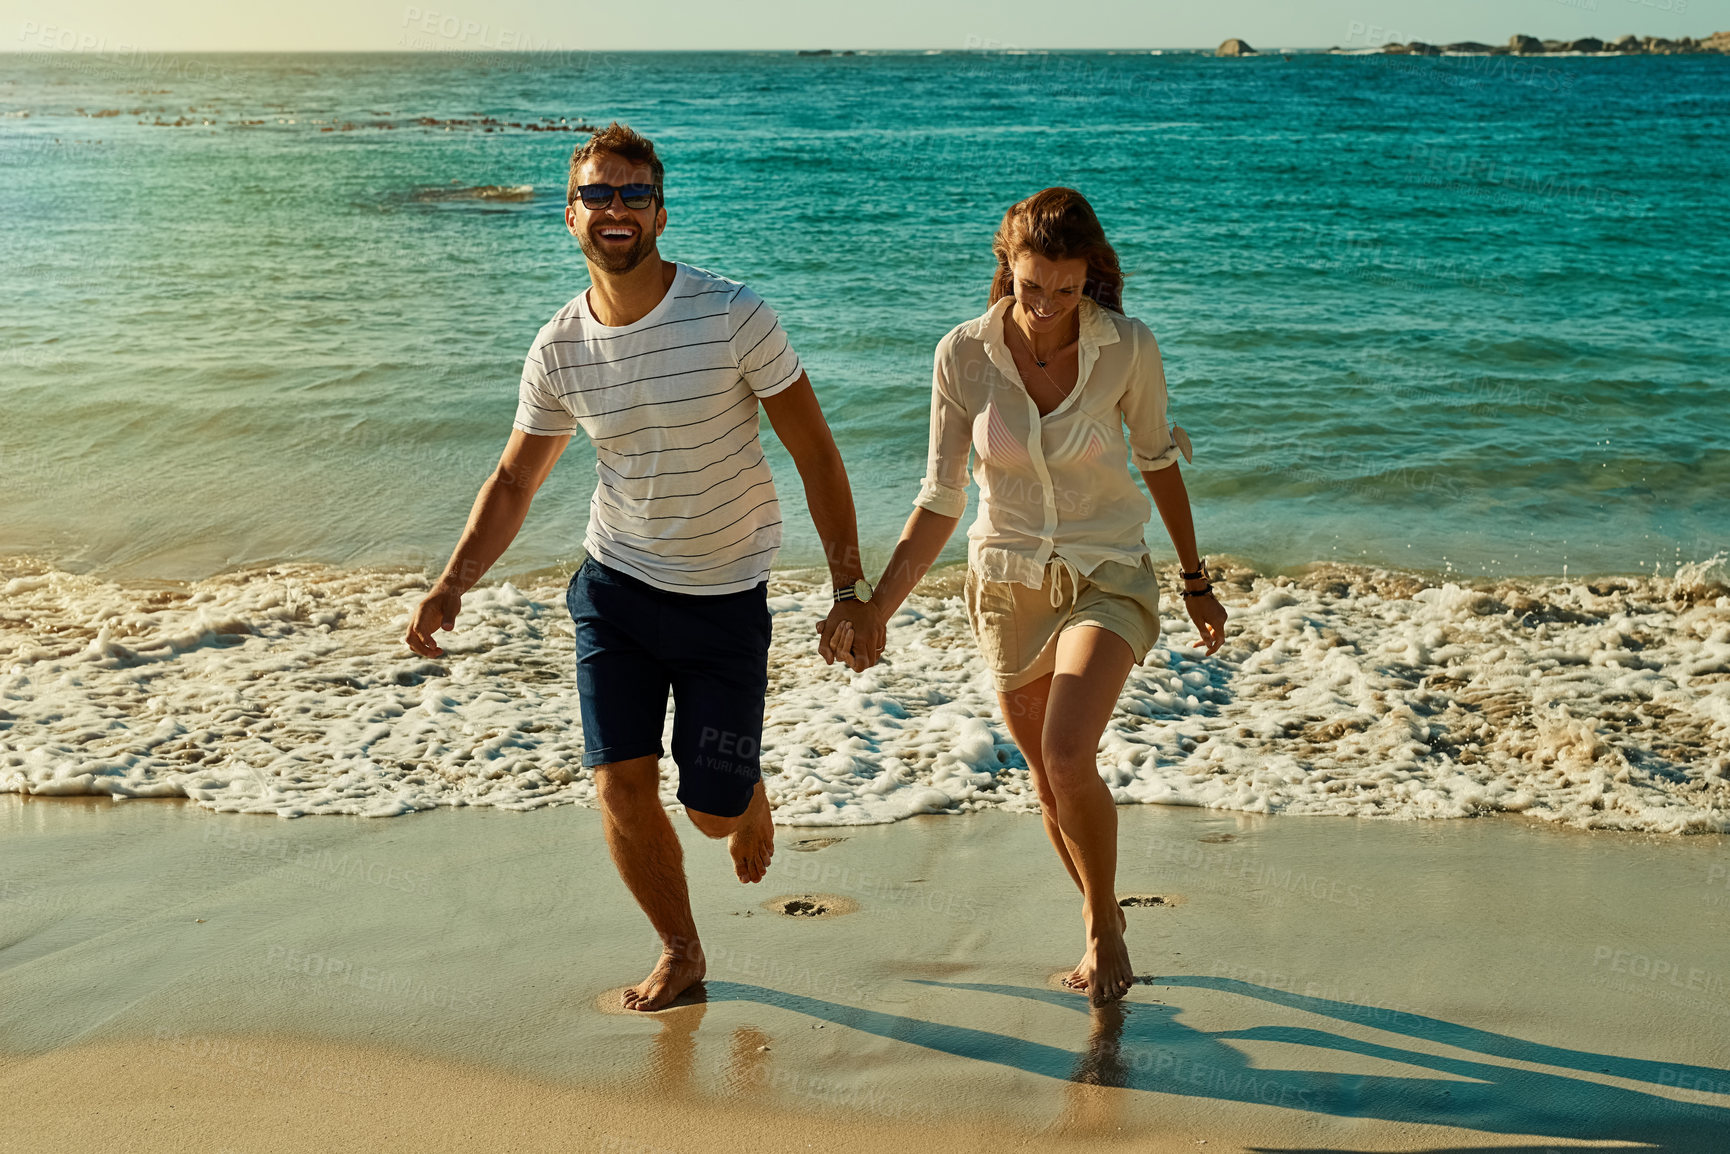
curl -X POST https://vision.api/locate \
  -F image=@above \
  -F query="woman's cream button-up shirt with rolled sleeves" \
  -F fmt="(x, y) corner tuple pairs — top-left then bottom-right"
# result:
(913, 296), (1178, 588)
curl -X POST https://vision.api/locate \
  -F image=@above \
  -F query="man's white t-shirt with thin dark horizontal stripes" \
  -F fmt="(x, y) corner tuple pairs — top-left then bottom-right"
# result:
(516, 265), (803, 593)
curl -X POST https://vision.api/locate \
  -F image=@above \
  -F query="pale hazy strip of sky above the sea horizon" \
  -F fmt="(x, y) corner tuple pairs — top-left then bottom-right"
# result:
(0, 0), (1730, 52)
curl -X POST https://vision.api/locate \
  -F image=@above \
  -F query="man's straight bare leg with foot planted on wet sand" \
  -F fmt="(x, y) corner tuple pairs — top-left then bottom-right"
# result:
(595, 758), (704, 1010)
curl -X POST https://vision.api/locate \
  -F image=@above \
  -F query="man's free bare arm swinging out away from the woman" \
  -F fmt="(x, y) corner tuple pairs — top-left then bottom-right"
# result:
(403, 429), (571, 657)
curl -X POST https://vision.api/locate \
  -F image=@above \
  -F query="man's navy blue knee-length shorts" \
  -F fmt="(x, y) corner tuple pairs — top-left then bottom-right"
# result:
(564, 557), (772, 817)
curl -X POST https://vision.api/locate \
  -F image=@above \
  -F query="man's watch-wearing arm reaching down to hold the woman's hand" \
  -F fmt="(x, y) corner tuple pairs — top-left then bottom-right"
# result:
(761, 372), (884, 671)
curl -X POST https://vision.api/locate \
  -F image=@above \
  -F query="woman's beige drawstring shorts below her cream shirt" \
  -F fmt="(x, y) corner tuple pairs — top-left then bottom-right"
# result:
(967, 557), (1159, 692)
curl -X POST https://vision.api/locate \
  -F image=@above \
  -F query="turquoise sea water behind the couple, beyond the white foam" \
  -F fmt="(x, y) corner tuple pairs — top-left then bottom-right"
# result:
(0, 52), (1730, 576)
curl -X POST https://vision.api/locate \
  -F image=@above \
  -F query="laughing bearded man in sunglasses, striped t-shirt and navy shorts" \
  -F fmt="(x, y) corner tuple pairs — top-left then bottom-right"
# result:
(405, 123), (870, 1010)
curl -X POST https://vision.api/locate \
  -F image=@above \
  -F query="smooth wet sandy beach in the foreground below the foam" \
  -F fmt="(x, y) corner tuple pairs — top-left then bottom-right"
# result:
(0, 798), (1730, 1151)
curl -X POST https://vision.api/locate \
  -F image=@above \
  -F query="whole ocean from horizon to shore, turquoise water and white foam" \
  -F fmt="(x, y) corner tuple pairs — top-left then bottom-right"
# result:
(0, 49), (1730, 830)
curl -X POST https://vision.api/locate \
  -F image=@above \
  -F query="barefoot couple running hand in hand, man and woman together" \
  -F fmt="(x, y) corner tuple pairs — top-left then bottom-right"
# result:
(405, 125), (1227, 1010)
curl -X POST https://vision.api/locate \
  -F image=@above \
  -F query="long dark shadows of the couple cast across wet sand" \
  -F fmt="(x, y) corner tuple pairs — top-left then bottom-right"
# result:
(688, 976), (1730, 1154)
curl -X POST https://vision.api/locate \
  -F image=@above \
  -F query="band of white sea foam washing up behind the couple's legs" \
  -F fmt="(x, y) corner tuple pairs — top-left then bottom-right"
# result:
(0, 557), (1730, 832)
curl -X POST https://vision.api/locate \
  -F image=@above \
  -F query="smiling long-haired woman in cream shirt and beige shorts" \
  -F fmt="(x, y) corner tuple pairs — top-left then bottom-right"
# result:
(823, 189), (1225, 1005)
